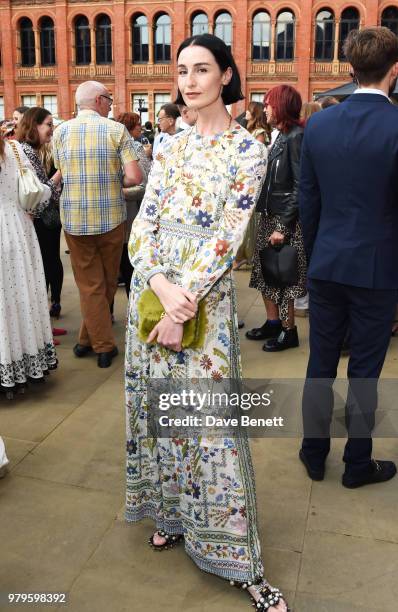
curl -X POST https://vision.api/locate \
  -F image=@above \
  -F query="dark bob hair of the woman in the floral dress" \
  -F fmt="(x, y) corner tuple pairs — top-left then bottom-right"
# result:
(175, 34), (244, 106)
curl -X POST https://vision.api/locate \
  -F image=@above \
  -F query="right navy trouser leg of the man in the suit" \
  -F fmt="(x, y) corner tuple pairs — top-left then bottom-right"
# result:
(343, 287), (396, 476)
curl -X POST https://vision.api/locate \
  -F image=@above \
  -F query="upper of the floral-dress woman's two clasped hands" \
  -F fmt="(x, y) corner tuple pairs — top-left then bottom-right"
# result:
(149, 273), (198, 323)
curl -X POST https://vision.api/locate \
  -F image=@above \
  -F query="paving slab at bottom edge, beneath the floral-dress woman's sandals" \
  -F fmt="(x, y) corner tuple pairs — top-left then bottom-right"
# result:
(62, 520), (299, 612)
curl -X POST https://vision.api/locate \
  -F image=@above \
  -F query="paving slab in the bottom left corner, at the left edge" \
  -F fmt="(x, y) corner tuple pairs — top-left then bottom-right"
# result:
(0, 473), (121, 592)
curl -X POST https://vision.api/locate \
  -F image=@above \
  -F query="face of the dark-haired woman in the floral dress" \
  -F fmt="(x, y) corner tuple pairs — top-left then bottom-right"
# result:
(178, 45), (232, 111)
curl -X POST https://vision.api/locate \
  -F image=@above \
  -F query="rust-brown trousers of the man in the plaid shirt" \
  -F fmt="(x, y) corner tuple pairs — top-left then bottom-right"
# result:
(65, 223), (125, 353)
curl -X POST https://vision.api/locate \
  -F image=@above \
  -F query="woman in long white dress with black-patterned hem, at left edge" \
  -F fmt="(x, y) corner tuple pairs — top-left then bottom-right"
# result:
(0, 138), (57, 398)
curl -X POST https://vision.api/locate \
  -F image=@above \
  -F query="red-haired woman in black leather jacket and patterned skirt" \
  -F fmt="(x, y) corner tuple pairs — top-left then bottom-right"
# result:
(246, 85), (306, 352)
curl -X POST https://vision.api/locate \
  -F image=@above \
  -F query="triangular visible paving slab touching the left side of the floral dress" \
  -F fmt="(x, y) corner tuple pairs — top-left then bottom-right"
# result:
(16, 369), (125, 495)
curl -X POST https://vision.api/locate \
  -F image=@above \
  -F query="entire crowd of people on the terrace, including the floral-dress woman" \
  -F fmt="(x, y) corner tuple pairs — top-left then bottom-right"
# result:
(0, 22), (398, 612)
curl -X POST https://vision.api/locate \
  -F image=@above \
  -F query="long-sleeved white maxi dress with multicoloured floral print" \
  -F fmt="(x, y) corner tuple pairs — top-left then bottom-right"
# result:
(126, 126), (267, 580)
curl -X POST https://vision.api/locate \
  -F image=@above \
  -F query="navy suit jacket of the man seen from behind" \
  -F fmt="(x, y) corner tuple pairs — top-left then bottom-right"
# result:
(299, 93), (398, 289)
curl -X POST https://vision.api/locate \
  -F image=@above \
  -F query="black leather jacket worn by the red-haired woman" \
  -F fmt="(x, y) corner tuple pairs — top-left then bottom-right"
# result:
(257, 126), (304, 230)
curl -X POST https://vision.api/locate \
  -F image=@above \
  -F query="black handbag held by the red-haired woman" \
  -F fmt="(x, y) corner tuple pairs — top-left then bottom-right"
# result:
(260, 244), (298, 289)
